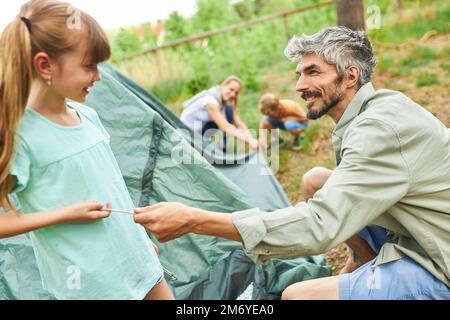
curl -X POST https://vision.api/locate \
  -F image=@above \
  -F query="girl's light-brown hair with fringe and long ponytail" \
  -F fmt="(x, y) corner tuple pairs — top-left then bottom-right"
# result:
(0, 0), (111, 209)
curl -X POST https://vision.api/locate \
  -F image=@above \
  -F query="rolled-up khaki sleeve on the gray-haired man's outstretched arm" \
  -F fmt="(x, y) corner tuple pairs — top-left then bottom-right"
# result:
(232, 119), (411, 262)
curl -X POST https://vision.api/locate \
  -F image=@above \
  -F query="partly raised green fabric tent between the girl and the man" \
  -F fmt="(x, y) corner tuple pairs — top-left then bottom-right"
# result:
(0, 65), (330, 299)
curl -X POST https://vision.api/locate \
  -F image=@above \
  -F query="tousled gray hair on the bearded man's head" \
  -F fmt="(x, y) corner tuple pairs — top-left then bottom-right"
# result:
(284, 27), (377, 87)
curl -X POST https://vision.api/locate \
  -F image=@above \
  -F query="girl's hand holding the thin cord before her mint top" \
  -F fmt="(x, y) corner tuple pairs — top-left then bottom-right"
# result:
(61, 202), (111, 223)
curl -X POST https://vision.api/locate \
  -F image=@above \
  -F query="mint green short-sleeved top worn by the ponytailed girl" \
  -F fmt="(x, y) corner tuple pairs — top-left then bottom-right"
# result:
(12, 102), (163, 300)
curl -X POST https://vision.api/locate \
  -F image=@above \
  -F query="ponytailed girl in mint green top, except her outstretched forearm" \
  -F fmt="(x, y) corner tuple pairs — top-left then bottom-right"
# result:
(0, 0), (173, 299)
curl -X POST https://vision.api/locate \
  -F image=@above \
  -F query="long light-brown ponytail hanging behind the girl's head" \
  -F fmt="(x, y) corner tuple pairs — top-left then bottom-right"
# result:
(0, 17), (33, 209)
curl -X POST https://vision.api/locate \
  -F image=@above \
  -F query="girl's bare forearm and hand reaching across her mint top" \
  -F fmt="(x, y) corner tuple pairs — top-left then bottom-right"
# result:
(0, 202), (110, 239)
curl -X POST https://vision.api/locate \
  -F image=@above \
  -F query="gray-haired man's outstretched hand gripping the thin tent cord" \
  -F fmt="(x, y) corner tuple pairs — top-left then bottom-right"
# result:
(134, 202), (193, 242)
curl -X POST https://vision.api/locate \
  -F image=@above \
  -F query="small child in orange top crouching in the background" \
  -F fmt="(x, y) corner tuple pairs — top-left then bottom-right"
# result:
(259, 93), (308, 150)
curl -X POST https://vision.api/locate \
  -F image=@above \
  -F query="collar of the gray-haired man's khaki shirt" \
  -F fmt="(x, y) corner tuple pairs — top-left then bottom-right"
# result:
(333, 82), (375, 139)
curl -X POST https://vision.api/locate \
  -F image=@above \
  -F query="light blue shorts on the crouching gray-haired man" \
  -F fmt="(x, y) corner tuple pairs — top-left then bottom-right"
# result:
(339, 257), (450, 300)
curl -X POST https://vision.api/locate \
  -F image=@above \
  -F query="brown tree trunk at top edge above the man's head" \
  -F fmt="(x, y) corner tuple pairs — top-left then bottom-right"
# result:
(336, 0), (366, 30)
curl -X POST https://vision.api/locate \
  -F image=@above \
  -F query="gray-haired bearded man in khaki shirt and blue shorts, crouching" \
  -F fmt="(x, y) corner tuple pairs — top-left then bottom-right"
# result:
(135, 27), (450, 299)
